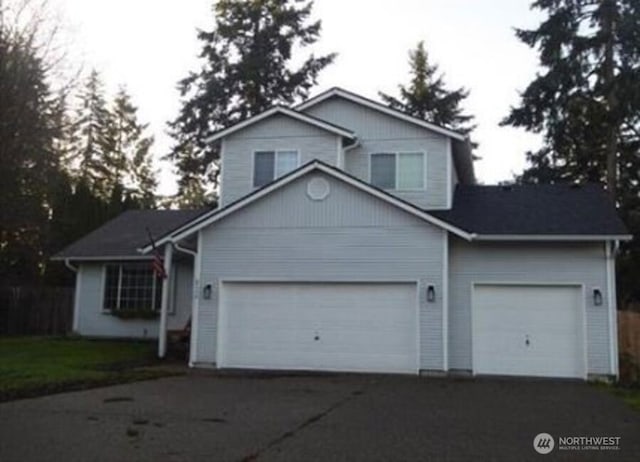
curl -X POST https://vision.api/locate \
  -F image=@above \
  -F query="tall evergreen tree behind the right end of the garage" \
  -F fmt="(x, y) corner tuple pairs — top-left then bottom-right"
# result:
(503, 0), (640, 300)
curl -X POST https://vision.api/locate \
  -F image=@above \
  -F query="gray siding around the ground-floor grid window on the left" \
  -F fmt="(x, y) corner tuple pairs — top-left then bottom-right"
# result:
(76, 263), (193, 338)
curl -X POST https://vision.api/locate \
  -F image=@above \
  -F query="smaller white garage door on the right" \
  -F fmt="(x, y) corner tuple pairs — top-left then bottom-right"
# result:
(472, 285), (585, 378)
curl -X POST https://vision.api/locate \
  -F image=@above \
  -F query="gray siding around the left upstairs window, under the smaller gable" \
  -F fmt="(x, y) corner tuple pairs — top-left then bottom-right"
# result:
(220, 115), (341, 205)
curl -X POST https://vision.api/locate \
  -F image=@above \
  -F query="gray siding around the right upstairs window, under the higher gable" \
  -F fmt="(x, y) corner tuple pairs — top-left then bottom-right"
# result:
(305, 98), (450, 209)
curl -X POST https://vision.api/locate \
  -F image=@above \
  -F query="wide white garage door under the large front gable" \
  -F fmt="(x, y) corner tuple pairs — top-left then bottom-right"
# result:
(218, 283), (418, 373)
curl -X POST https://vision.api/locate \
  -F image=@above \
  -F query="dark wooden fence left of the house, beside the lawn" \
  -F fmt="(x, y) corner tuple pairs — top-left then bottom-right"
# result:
(0, 287), (74, 335)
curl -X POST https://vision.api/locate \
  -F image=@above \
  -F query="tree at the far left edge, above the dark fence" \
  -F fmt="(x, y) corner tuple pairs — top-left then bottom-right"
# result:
(0, 3), (59, 285)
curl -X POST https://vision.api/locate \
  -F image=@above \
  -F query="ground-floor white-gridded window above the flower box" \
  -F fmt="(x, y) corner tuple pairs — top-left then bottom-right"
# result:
(103, 262), (162, 311)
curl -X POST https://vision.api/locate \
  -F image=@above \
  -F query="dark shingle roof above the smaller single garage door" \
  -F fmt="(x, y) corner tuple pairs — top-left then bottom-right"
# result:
(430, 184), (628, 236)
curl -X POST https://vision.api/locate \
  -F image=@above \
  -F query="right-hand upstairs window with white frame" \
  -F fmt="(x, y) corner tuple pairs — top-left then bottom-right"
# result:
(370, 152), (425, 191)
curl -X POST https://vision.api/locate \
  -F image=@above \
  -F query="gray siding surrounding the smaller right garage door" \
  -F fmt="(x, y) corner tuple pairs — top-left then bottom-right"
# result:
(449, 237), (611, 374)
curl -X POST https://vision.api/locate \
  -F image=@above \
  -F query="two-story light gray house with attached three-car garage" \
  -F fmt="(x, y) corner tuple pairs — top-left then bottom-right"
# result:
(56, 88), (629, 378)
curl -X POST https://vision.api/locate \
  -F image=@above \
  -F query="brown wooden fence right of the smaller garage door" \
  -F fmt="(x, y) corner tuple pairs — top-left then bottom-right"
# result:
(618, 311), (640, 382)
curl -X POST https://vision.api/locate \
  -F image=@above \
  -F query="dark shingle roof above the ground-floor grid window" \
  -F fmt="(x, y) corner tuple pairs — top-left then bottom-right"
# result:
(53, 209), (209, 259)
